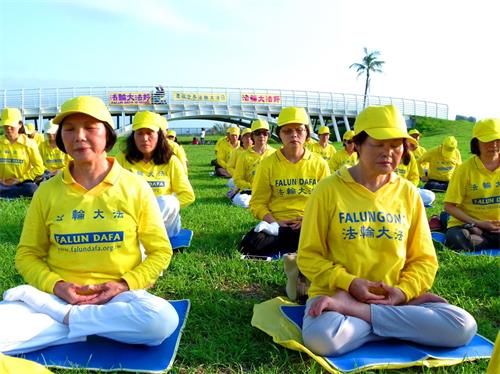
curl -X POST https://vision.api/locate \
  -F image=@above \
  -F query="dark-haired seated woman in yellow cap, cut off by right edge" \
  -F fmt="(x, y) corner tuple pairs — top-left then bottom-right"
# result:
(444, 118), (500, 251)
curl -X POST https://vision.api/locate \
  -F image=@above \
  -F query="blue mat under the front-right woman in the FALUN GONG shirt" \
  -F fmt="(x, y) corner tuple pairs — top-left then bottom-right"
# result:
(281, 305), (493, 372)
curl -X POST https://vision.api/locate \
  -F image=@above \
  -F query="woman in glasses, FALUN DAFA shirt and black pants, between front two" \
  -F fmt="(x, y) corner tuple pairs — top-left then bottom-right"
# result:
(240, 107), (330, 256)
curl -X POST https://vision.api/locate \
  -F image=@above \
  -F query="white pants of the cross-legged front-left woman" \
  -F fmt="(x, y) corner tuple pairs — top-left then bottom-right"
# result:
(0, 290), (179, 354)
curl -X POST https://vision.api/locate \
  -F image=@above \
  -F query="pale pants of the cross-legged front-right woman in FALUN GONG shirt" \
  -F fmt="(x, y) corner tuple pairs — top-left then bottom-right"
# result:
(302, 296), (477, 356)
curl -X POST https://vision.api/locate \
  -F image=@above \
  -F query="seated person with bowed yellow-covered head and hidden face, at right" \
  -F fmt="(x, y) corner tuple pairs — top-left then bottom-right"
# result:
(418, 136), (462, 192)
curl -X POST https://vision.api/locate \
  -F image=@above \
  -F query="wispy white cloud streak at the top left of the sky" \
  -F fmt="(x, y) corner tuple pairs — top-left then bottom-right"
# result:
(64, 0), (210, 33)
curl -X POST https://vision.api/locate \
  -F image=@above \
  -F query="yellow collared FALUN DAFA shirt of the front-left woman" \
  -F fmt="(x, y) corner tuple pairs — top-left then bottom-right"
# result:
(16, 158), (172, 293)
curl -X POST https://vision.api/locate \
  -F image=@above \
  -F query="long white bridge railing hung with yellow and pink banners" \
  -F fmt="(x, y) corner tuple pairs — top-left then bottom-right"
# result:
(0, 86), (448, 118)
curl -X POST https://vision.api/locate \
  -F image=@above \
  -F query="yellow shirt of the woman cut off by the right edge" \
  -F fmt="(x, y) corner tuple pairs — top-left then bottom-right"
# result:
(444, 155), (500, 227)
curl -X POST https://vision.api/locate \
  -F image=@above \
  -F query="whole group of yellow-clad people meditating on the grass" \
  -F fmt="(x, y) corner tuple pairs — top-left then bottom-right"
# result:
(0, 96), (494, 368)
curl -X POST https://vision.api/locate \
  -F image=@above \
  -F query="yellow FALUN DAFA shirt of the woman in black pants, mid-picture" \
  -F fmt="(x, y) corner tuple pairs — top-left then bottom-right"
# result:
(250, 149), (330, 221)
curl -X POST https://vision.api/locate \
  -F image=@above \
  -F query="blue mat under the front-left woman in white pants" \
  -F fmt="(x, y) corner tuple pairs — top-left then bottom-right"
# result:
(16, 299), (190, 373)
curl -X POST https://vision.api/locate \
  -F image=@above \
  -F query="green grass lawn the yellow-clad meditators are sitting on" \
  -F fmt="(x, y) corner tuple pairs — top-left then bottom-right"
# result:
(0, 124), (500, 373)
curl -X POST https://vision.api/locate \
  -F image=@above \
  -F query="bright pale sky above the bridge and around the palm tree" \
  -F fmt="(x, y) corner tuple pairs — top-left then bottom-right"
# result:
(0, 0), (500, 118)
